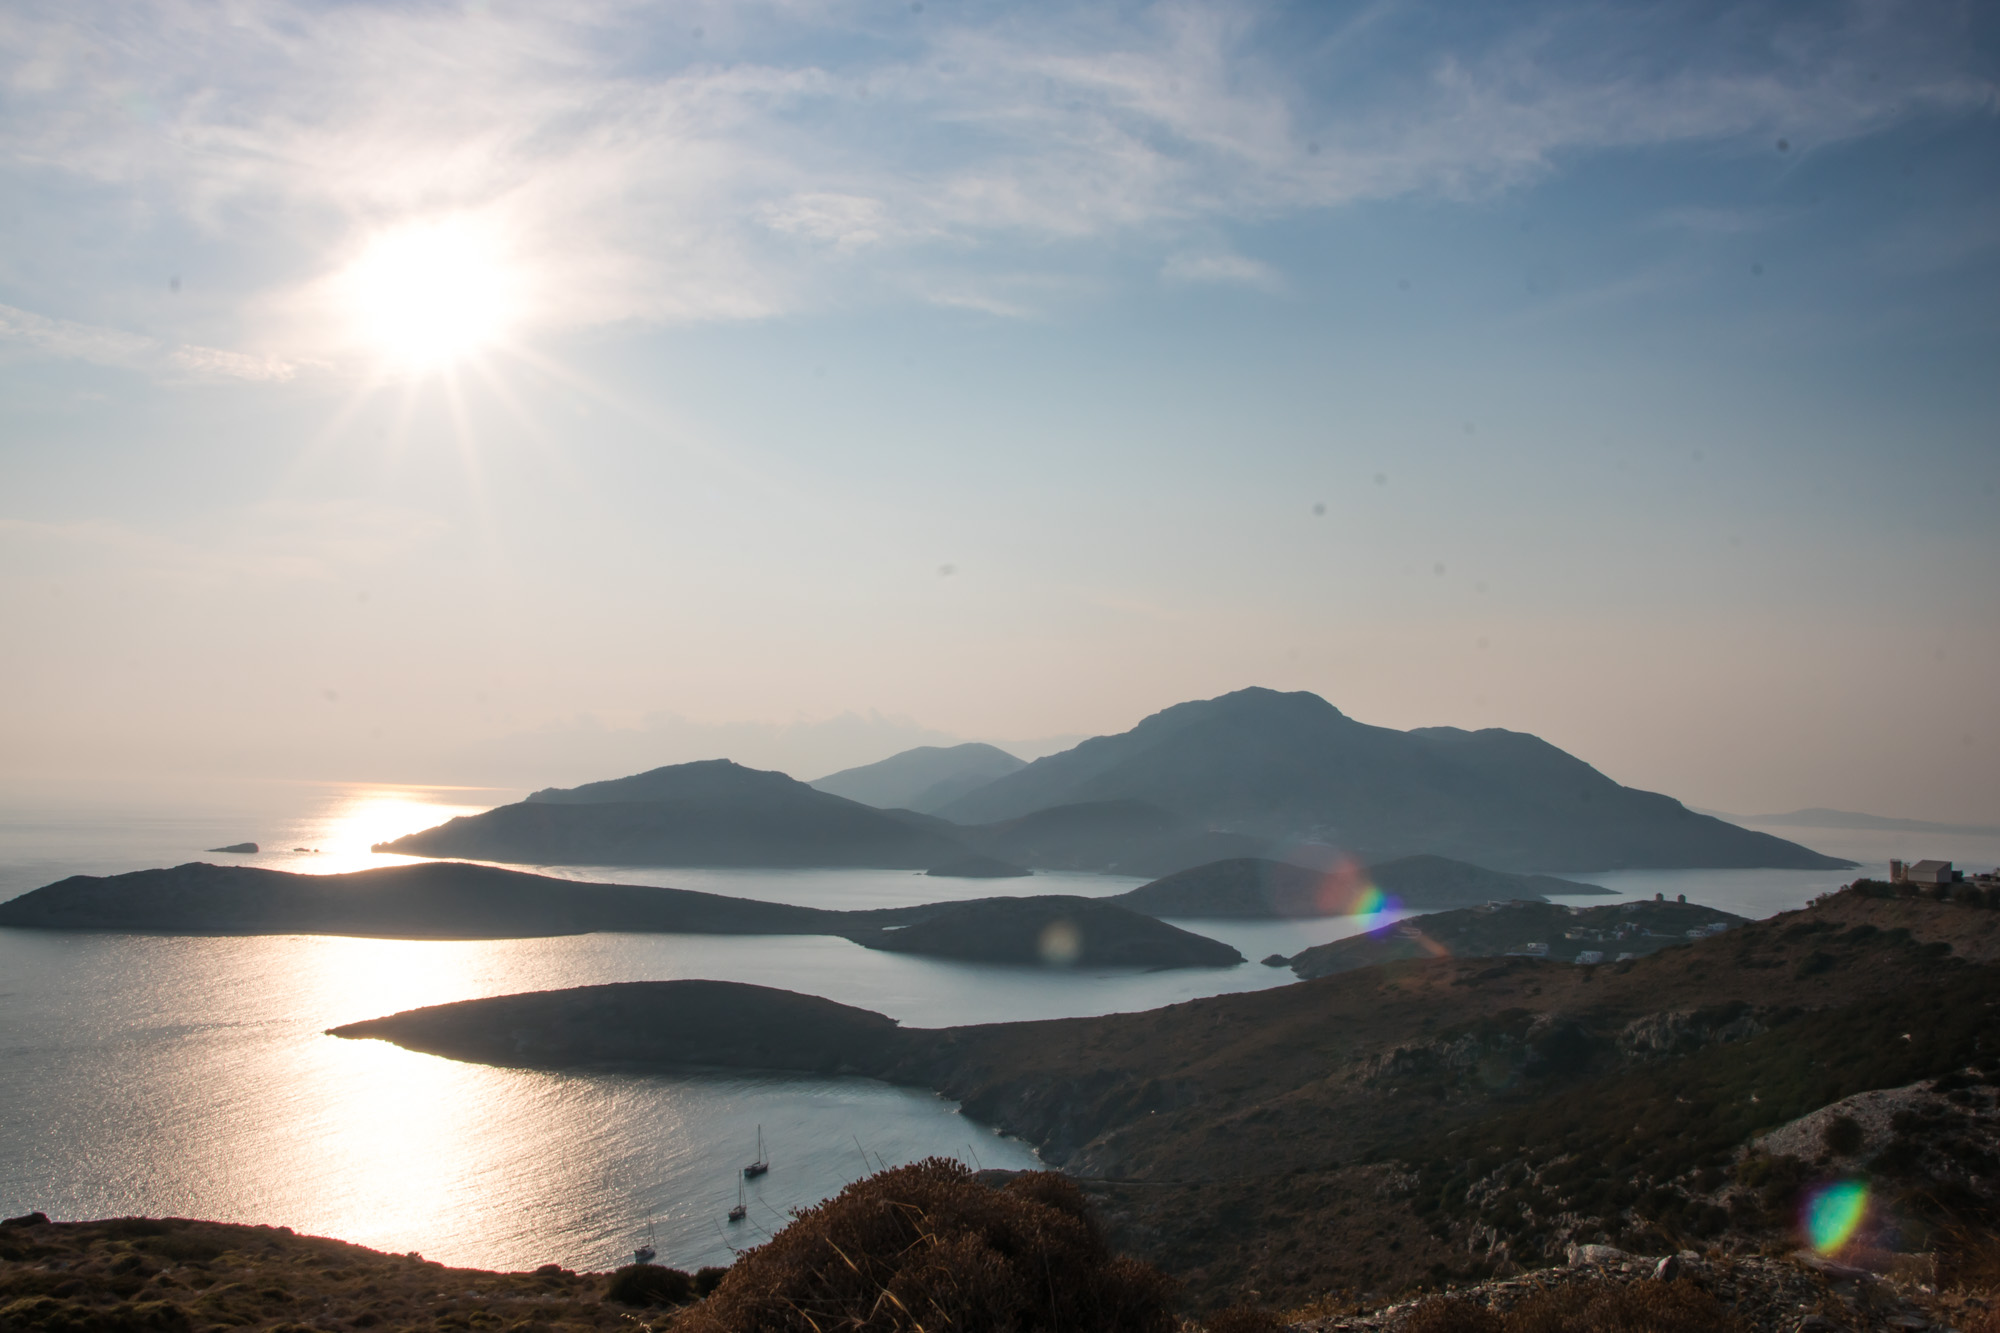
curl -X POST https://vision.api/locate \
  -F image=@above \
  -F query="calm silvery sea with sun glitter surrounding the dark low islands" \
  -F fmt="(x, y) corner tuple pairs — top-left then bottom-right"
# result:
(0, 783), (2000, 1271)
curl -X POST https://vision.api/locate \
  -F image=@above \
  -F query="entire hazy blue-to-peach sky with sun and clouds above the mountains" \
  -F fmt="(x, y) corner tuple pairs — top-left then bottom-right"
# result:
(0, 0), (2000, 823)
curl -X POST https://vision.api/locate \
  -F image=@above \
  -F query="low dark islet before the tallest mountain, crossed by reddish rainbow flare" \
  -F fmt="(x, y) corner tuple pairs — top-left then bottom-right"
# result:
(1110, 857), (1608, 919)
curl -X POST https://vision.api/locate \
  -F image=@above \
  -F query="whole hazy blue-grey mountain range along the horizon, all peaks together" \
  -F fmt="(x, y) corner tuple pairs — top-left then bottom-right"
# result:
(378, 689), (1852, 877)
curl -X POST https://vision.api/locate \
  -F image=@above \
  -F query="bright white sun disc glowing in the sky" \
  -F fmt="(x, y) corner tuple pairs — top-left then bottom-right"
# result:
(342, 218), (518, 372)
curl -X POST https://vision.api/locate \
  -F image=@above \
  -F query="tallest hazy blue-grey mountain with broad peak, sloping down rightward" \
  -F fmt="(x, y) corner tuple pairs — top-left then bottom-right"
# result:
(938, 689), (1852, 871)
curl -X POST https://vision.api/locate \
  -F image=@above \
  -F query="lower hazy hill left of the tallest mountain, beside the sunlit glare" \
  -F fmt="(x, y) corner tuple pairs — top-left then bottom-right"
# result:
(376, 759), (972, 869)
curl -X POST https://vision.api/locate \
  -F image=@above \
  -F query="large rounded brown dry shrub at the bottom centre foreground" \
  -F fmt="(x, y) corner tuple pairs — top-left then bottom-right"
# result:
(674, 1157), (1174, 1333)
